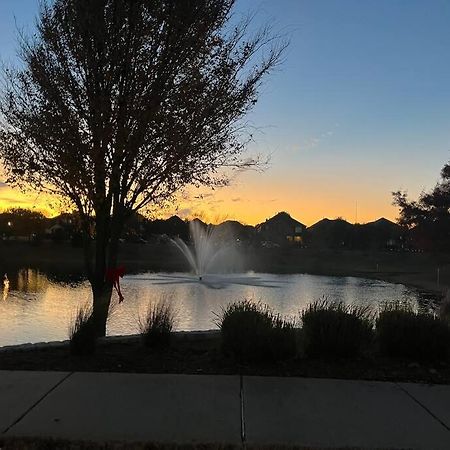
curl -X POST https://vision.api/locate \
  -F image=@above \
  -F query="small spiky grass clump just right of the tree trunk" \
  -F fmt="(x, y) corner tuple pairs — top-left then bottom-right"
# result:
(138, 300), (175, 348)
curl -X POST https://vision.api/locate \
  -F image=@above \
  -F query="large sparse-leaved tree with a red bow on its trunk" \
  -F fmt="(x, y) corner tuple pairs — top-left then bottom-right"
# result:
(0, 0), (286, 335)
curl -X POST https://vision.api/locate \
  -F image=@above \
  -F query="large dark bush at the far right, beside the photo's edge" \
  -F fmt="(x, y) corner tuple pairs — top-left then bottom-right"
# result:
(376, 303), (450, 360)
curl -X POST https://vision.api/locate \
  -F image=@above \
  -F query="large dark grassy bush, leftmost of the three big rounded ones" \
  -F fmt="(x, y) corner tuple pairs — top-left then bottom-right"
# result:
(216, 300), (297, 362)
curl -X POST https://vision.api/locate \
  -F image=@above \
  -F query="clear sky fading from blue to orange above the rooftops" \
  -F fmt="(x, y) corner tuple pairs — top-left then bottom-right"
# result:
(0, 0), (450, 225)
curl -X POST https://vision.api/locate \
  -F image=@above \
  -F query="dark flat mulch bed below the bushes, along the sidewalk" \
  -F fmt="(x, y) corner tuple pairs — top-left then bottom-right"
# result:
(0, 333), (450, 384)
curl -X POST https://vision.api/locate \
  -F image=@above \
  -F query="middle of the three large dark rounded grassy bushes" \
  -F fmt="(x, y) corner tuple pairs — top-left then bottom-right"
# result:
(301, 299), (373, 358)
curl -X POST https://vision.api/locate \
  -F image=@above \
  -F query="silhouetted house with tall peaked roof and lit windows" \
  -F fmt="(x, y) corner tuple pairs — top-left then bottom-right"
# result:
(255, 212), (306, 246)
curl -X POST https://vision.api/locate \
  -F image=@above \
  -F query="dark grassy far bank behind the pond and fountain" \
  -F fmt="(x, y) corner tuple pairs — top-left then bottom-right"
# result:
(0, 241), (450, 293)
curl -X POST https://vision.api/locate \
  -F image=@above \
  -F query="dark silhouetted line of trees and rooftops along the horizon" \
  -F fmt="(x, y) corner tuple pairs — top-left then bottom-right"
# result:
(0, 208), (429, 250)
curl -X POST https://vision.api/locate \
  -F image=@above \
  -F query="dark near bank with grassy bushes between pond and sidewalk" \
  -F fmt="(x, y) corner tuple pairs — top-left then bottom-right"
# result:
(0, 299), (450, 384)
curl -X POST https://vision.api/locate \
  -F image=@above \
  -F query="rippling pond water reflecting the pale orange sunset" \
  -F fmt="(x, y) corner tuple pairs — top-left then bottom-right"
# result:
(0, 269), (434, 346)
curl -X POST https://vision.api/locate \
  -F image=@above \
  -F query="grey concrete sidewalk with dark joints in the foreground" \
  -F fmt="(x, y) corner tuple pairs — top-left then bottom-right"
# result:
(0, 371), (450, 450)
